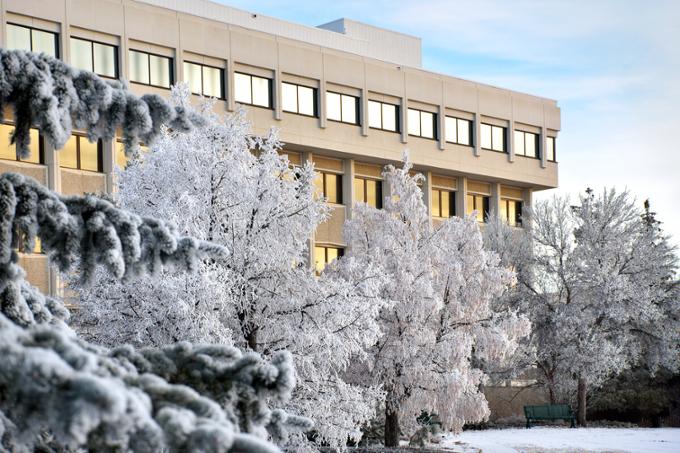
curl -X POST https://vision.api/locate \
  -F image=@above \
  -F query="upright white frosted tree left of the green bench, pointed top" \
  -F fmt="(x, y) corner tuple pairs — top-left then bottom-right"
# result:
(332, 155), (529, 446)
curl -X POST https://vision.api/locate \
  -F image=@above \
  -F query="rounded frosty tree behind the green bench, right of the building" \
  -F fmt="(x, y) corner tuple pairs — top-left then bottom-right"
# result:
(485, 190), (680, 425)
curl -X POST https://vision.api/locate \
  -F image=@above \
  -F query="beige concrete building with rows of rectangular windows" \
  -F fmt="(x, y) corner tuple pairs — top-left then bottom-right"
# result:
(0, 0), (560, 294)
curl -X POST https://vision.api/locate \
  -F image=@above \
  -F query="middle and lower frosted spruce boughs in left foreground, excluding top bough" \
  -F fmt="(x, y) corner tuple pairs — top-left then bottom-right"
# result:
(0, 173), (310, 452)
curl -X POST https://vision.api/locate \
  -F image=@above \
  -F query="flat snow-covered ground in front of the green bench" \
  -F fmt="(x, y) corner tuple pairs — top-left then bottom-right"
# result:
(441, 427), (680, 453)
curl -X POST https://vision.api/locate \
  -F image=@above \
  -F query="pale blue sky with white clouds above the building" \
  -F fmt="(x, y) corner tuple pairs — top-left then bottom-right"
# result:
(222, 0), (680, 244)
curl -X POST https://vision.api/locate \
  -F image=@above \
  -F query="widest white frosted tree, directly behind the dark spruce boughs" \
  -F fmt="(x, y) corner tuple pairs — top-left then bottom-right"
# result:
(73, 90), (388, 448)
